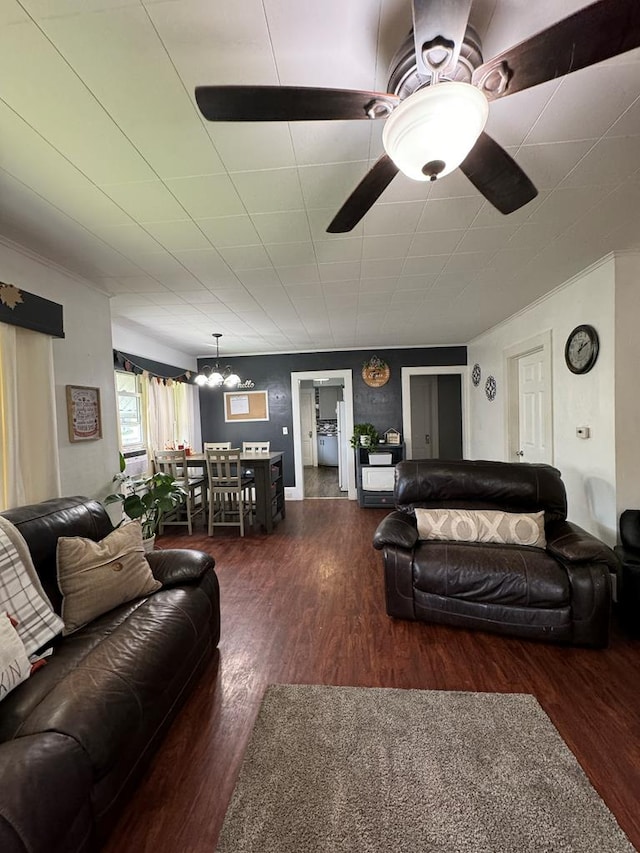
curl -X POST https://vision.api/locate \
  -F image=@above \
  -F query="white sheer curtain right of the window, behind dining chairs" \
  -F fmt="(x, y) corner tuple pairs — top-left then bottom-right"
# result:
(142, 376), (200, 453)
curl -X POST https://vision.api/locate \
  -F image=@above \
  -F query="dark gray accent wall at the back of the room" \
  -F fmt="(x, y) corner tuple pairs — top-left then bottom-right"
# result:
(198, 347), (467, 486)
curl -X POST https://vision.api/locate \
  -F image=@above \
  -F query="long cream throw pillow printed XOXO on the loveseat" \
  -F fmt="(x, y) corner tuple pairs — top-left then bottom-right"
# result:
(416, 507), (547, 548)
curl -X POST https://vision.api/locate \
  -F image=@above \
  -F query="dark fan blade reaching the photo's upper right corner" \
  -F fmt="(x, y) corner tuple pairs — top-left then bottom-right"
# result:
(472, 0), (640, 100)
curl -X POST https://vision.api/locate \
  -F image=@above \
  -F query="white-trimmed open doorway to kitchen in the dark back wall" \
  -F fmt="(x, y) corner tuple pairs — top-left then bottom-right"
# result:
(287, 370), (356, 500)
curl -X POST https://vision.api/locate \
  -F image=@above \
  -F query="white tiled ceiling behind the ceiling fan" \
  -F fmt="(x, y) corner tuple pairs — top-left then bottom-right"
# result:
(0, 0), (640, 355)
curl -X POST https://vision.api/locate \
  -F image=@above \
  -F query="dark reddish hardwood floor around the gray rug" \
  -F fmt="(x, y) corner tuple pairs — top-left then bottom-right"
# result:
(106, 500), (640, 853)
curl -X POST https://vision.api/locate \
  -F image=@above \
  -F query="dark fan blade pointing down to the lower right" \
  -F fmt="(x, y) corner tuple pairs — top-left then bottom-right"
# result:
(460, 133), (538, 214)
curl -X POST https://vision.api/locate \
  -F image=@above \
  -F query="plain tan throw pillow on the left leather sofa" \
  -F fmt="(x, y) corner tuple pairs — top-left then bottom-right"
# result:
(57, 521), (162, 635)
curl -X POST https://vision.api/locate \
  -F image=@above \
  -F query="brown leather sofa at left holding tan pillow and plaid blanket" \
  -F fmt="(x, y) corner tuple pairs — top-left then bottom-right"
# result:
(0, 497), (220, 853)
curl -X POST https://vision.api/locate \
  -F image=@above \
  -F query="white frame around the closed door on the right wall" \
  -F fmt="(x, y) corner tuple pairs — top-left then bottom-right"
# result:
(503, 329), (554, 465)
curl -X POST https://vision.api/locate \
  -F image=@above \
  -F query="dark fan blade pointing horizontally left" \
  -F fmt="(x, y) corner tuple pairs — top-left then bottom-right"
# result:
(196, 86), (400, 121)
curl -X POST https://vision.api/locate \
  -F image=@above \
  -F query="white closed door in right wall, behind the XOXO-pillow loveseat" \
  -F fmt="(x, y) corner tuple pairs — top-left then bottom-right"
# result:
(516, 349), (550, 462)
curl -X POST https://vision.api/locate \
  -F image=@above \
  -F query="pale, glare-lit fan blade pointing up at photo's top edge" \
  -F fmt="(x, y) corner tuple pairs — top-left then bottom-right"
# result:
(412, 0), (472, 77)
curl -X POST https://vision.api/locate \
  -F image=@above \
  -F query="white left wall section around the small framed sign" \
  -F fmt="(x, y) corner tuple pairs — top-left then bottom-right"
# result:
(0, 240), (118, 497)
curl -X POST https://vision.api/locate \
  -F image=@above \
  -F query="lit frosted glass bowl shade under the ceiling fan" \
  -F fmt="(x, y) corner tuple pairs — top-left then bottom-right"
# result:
(382, 83), (489, 181)
